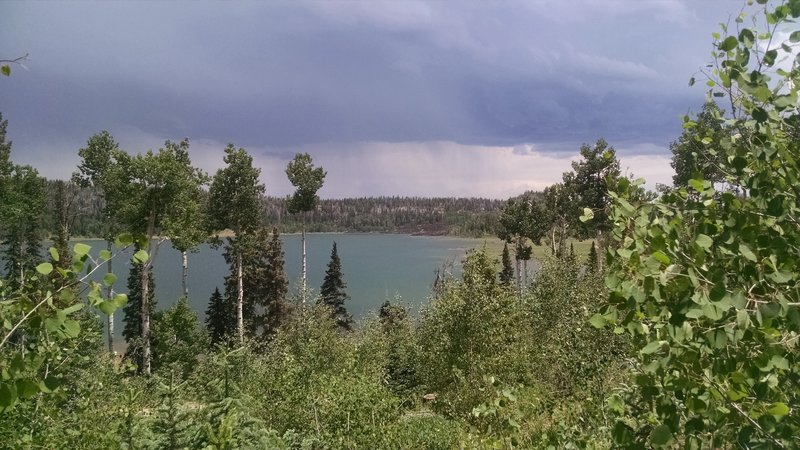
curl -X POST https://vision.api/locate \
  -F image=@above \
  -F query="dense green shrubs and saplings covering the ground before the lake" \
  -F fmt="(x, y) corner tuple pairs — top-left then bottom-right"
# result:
(0, 246), (625, 449)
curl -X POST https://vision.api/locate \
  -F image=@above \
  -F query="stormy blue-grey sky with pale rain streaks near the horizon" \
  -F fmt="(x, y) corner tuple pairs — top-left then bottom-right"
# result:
(0, 0), (743, 198)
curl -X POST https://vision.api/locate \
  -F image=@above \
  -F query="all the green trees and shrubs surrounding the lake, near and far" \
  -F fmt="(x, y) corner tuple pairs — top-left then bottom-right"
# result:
(0, 0), (800, 449)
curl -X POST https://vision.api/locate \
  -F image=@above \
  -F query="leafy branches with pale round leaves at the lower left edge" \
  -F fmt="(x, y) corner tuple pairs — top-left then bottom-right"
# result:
(0, 236), (137, 412)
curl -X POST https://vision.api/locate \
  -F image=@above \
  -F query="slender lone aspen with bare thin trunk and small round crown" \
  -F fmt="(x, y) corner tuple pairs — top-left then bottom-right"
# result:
(286, 153), (326, 304)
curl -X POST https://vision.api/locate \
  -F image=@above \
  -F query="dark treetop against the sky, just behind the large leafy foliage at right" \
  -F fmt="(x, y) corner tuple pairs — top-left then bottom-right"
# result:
(669, 101), (728, 187)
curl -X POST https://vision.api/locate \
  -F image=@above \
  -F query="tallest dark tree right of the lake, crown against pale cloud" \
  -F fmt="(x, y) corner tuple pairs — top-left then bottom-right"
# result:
(563, 139), (620, 239)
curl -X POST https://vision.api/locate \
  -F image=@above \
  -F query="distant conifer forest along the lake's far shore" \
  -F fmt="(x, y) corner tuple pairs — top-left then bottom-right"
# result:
(43, 180), (504, 237)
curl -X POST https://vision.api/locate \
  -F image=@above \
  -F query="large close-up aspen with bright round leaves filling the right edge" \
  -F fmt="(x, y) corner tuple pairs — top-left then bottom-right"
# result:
(592, 4), (800, 448)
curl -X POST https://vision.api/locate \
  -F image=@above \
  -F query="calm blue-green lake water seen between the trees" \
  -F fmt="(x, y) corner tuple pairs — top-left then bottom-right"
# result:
(87, 233), (494, 330)
